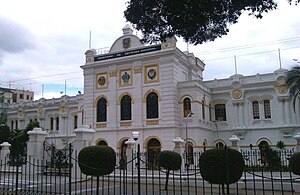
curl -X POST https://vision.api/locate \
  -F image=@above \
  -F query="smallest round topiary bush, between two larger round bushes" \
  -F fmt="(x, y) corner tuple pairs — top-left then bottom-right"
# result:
(158, 150), (182, 170)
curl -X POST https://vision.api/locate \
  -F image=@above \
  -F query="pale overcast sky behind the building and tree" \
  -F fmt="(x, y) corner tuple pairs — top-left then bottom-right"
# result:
(0, 0), (300, 98)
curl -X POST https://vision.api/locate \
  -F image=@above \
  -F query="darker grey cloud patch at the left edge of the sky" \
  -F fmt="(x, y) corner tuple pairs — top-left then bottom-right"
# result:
(0, 16), (35, 54)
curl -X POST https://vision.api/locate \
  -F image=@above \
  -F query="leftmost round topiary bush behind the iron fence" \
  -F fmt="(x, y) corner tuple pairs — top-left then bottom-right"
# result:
(78, 146), (116, 176)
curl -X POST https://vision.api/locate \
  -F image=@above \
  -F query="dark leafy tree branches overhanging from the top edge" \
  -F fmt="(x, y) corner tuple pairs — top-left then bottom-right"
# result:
(124, 0), (300, 45)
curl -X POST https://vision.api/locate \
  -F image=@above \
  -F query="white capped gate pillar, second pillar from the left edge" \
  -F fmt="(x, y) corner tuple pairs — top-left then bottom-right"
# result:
(27, 128), (48, 159)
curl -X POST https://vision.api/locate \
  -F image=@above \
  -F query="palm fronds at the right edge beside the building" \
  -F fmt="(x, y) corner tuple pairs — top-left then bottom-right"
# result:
(286, 65), (300, 109)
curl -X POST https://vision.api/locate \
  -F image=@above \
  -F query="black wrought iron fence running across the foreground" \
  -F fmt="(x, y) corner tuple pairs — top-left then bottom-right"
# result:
(0, 145), (300, 195)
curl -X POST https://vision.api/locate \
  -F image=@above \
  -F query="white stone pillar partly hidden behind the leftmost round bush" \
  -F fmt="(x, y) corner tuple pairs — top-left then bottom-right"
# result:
(74, 125), (95, 153)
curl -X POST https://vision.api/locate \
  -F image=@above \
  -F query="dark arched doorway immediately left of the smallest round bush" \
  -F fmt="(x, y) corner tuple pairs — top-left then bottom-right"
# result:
(146, 138), (161, 169)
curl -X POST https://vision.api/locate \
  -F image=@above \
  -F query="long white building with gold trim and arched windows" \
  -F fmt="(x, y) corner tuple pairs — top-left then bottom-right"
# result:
(7, 26), (300, 166)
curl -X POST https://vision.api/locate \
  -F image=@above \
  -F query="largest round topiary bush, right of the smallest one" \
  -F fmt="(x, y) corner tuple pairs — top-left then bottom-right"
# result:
(199, 147), (245, 184)
